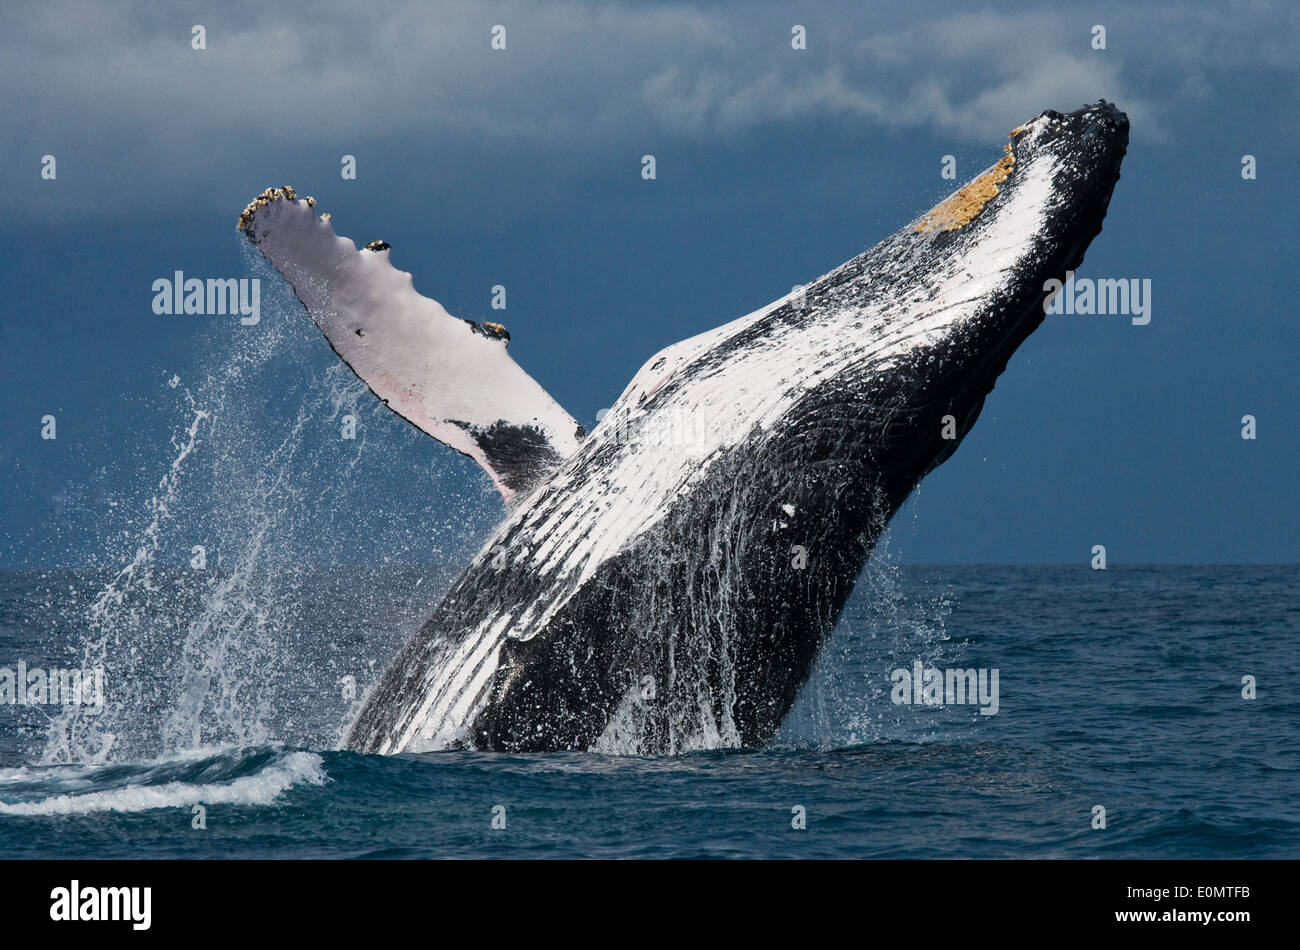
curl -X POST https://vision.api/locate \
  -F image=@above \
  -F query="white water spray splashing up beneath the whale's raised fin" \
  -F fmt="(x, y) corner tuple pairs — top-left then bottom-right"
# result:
(35, 248), (493, 765)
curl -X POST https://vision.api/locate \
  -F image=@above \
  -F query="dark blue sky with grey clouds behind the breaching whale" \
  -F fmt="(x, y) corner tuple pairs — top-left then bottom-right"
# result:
(0, 1), (1300, 565)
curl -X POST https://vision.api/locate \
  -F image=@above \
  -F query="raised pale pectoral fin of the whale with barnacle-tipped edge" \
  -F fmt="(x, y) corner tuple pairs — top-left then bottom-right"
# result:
(239, 186), (582, 502)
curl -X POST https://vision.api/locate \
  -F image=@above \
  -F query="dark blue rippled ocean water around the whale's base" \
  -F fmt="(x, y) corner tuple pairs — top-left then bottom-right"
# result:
(0, 555), (1300, 858)
